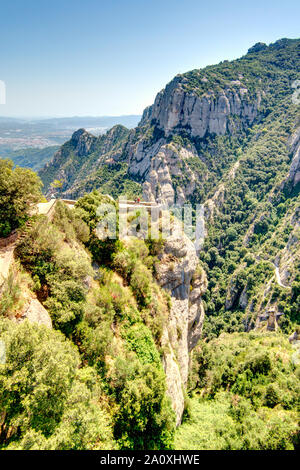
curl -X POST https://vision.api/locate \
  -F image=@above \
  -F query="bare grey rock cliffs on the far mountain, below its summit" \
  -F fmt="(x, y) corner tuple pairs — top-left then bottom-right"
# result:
(128, 79), (261, 206)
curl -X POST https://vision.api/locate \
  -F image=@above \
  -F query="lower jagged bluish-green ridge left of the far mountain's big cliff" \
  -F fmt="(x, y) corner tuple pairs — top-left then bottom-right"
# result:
(39, 125), (140, 198)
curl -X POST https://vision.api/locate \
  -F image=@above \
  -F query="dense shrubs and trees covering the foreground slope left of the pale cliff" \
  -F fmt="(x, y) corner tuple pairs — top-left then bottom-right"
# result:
(0, 192), (174, 449)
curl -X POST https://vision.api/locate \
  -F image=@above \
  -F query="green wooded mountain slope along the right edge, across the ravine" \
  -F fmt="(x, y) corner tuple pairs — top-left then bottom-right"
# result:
(200, 97), (300, 337)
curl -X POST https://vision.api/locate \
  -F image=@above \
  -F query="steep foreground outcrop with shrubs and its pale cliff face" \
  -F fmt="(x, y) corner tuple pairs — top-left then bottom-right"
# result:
(0, 192), (210, 449)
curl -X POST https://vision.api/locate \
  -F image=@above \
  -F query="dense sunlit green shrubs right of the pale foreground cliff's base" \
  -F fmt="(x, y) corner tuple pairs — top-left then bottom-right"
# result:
(175, 332), (300, 450)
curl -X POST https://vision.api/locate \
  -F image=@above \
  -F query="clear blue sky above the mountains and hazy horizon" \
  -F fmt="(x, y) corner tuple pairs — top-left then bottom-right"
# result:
(0, 0), (300, 116)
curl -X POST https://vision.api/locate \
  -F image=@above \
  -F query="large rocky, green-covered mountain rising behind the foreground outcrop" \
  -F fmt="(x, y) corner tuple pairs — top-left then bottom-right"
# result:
(41, 39), (300, 336)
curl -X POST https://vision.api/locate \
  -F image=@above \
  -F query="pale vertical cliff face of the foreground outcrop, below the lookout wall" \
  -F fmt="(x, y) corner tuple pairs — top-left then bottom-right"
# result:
(157, 218), (207, 425)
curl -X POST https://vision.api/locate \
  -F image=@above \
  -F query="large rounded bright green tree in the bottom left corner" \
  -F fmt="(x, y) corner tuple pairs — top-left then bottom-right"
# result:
(0, 320), (113, 449)
